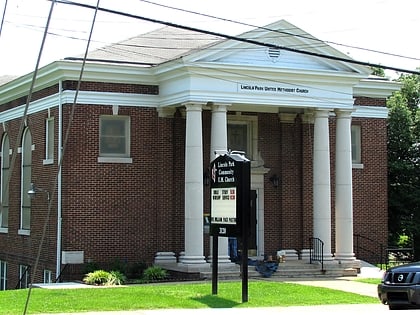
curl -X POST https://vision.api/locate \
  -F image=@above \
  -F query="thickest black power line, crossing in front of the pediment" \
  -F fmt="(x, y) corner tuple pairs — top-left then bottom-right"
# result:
(50, 0), (420, 75)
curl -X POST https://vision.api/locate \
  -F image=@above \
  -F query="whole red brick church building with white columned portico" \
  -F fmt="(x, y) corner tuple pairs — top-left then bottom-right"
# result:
(0, 20), (399, 289)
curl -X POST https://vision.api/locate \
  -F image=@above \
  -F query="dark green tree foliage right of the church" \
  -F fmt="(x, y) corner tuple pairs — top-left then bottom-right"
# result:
(387, 69), (420, 254)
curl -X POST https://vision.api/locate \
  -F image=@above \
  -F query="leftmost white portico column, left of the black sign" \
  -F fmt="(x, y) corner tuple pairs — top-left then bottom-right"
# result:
(180, 104), (206, 264)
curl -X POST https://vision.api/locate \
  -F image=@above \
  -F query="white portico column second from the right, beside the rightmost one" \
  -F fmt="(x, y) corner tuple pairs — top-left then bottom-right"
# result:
(313, 110), (332, 260)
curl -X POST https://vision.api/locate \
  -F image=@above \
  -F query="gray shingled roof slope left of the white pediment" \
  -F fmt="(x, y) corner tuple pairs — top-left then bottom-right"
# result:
(71, 26), (223, 65)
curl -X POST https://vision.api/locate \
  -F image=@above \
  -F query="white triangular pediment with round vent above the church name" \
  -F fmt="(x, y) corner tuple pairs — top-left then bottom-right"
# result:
(184, 20), (370, 74)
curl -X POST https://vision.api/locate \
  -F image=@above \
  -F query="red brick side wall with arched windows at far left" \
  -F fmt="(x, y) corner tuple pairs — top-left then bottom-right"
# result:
(0, 109), (58, 288)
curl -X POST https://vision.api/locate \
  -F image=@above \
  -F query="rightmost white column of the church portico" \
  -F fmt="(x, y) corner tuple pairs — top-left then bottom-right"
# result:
(335, 111), (355, 260)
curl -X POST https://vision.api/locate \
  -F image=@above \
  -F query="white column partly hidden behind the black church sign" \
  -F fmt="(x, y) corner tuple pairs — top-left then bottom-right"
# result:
(210, 104), (231, 264)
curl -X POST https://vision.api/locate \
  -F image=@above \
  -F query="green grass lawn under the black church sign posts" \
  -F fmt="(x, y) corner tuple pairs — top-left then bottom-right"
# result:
(0, 281), (378, 315)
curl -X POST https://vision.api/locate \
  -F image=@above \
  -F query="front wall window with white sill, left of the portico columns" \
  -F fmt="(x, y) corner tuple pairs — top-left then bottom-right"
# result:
(98, 115), (131, 163)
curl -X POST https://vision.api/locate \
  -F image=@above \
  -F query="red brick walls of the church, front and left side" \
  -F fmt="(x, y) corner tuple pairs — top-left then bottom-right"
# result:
(0, 82), (387, 287)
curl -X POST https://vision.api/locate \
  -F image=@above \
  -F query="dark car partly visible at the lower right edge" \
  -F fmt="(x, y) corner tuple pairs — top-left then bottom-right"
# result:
(378, 262), (420, 310)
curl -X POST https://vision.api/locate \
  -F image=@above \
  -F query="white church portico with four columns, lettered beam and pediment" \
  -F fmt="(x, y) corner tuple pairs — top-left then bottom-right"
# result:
(153, 21), (396, 267)
